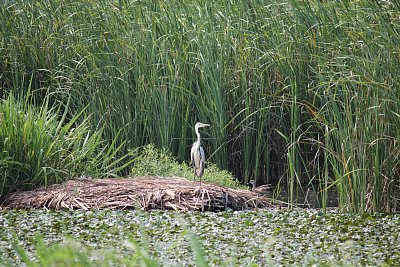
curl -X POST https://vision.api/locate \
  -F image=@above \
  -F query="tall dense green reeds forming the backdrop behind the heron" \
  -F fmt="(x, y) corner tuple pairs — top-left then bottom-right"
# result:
(0, 0), (400, 212)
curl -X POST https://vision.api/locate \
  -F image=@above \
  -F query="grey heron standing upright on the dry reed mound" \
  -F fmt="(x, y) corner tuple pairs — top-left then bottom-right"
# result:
(190, 122), (210, 185)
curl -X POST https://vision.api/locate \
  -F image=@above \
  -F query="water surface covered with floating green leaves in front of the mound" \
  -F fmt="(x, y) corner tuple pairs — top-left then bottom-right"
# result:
(0, 210), (400, 266)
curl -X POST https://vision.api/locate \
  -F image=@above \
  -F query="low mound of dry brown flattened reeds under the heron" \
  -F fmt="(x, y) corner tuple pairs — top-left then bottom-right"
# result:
(3, 177), (282, 211)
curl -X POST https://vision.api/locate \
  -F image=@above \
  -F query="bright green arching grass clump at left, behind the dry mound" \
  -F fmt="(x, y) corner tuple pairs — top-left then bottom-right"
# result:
(0, 94), (132, 196)
